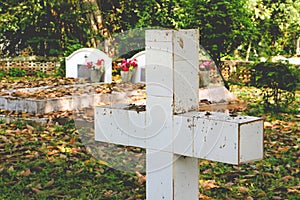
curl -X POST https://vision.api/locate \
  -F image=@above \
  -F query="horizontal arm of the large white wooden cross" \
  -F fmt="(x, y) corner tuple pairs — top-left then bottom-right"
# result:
(95, 104), (263, 164)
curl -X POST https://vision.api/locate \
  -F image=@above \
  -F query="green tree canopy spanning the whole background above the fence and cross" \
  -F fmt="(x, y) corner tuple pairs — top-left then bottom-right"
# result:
(0, 0), (300, 62)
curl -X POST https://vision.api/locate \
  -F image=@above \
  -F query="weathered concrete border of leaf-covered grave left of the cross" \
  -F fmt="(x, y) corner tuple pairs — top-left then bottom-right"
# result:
(0, 83), (141, 114)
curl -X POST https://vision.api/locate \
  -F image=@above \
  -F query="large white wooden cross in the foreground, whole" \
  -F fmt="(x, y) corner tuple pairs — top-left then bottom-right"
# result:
(95, 30), (263, 200)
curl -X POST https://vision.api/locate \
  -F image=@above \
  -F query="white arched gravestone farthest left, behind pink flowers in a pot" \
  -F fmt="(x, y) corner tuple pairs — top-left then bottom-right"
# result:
(66, 48), (112, 83)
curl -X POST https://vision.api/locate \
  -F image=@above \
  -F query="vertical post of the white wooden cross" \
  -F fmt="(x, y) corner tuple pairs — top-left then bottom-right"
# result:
(146, 30), (199, 200)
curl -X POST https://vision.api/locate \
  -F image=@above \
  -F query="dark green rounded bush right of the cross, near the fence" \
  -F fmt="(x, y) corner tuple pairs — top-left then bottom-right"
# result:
(250, 62), (299, 111)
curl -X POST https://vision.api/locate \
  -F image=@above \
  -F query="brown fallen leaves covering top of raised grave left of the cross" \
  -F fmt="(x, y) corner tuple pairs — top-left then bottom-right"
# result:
(0, 77), (145, 99)
